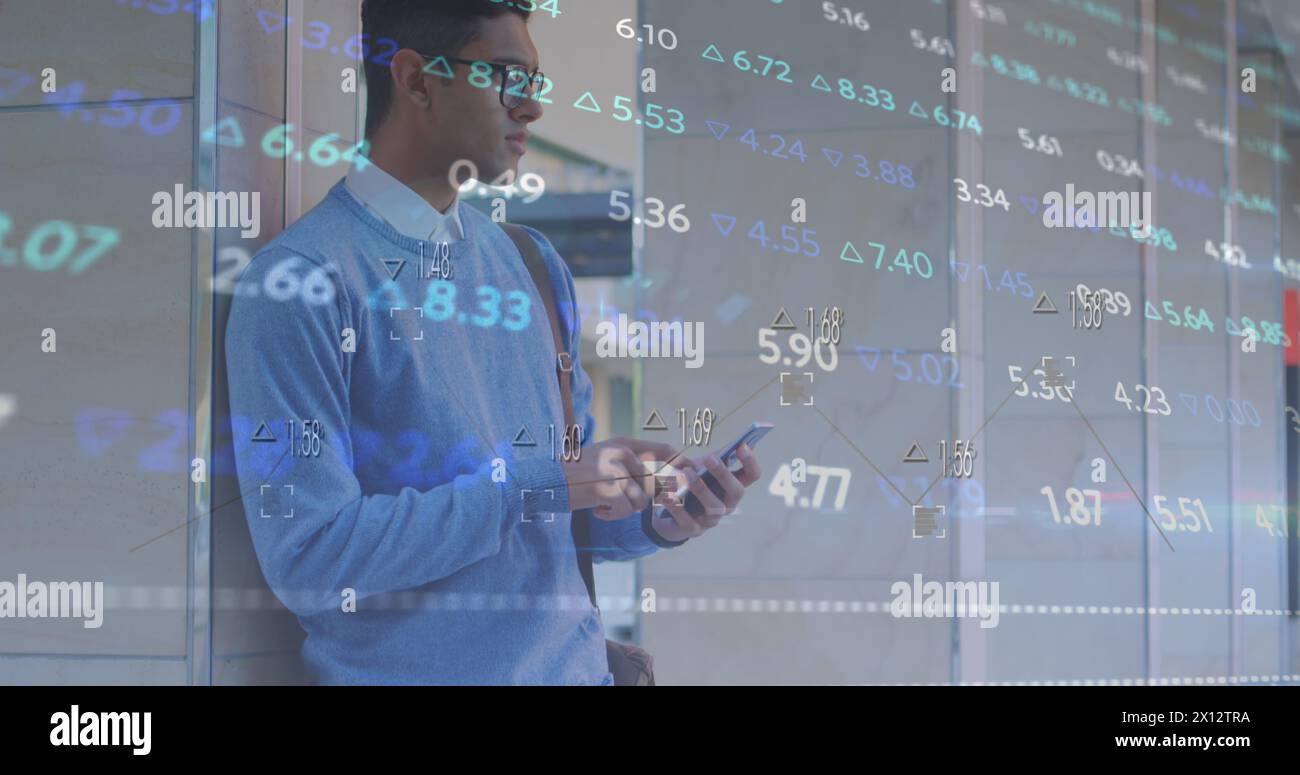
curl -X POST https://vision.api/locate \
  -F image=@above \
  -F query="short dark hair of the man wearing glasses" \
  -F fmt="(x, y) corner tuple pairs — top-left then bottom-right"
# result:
(361, 0), (532, 137)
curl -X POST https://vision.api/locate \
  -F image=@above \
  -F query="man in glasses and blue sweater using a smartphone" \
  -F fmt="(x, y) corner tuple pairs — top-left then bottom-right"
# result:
(218, 0), (759, 684)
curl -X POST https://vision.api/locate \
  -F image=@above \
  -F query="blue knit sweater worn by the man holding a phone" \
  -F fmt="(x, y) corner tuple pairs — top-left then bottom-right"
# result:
(226, 182), (668, 684)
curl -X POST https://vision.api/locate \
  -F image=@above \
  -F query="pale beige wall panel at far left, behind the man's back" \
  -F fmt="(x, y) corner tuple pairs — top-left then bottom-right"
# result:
(0, 0), (195, 683)
